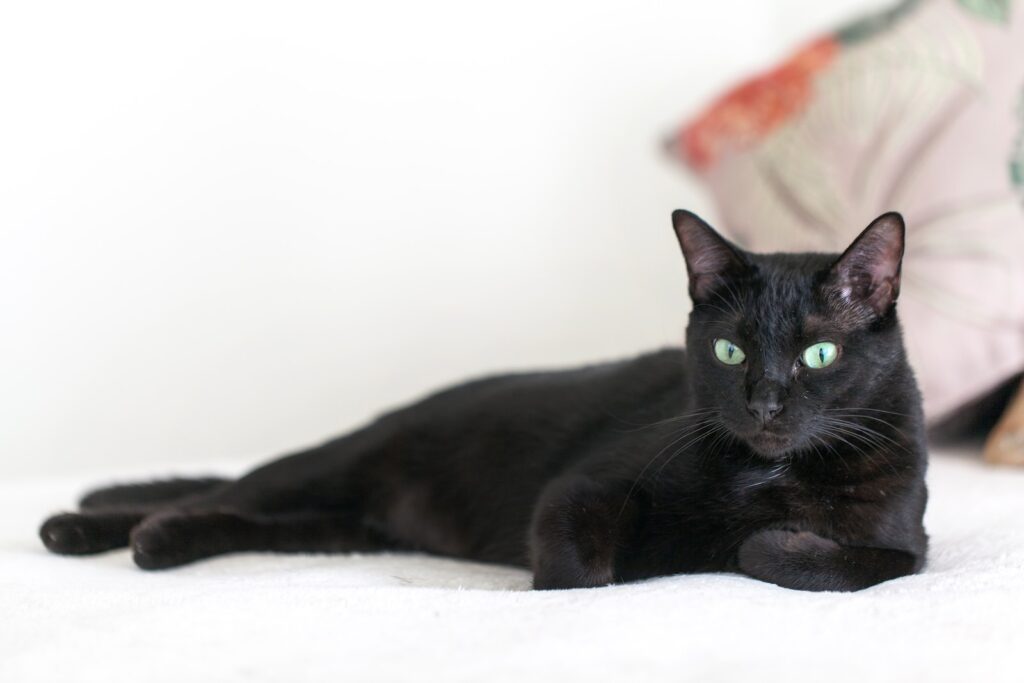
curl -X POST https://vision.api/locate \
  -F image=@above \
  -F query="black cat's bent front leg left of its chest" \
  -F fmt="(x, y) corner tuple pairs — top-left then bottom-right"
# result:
(529, 475), (635, 590)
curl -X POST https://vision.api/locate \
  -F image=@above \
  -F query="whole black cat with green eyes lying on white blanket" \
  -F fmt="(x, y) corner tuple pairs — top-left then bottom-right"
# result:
(40, 211), (928, 591)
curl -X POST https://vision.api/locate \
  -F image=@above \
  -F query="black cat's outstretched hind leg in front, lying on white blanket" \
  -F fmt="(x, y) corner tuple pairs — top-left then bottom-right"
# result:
(131, 508), (395, 569)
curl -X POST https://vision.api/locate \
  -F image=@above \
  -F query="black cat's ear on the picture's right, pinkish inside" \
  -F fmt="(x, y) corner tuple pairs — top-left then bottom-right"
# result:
(825, 212), (906, 317)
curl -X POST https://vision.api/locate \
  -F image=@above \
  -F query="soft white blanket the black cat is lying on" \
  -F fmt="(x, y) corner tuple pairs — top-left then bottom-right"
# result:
(0, 454), (1024, 683)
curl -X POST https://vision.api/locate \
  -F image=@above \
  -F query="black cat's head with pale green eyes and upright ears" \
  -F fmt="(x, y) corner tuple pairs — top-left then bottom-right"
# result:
(672, 211), (918, 459)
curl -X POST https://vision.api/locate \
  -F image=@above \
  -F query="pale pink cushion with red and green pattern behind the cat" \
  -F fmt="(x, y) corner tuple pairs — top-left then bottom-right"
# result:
(671, 0), (1024, 419)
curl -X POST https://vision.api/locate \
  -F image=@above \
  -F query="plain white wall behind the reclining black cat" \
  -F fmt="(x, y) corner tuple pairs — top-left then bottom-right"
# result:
(0, 0), (888, 475)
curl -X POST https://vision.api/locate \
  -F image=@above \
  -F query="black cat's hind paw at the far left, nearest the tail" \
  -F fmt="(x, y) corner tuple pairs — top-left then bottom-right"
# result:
(39, 509), (145, 555)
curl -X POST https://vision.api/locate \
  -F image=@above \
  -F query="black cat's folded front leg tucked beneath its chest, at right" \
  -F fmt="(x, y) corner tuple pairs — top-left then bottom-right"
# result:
(738, 529), (921, 591)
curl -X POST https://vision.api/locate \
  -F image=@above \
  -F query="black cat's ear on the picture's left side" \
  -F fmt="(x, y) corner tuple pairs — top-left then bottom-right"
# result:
(672, 209), (748, 303)
